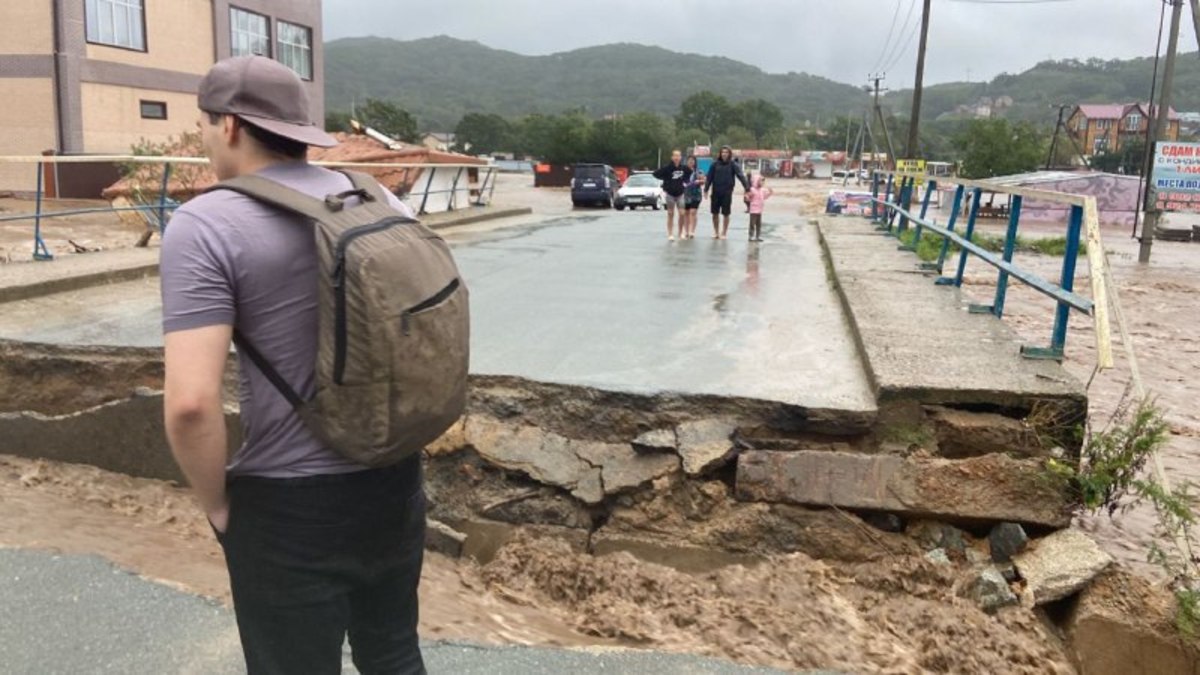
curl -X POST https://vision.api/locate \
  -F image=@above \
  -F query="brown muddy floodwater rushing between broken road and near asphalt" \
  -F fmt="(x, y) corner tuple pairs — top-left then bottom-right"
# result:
(0, 455), (1070, 673)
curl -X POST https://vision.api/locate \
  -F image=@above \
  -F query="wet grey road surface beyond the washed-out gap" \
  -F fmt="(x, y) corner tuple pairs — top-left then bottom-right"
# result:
(0, 210), (874, 410)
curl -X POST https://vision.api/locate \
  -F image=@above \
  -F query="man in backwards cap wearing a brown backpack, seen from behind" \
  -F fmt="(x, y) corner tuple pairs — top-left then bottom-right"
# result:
(161, 56), (468, 674)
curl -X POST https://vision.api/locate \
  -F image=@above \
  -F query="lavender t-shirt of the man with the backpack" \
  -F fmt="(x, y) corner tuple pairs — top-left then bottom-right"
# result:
(161, 162), (412, 478)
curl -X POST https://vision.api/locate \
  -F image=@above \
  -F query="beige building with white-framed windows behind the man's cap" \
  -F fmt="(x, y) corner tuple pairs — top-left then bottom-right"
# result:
(0, 0), (324, 191)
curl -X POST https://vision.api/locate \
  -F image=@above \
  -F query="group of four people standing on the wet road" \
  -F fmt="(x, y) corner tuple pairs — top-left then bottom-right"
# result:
(654, 145), (772, 241)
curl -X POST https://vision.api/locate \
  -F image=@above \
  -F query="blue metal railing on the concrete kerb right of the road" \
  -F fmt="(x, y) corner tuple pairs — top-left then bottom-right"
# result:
(871, 172), (1094, 360)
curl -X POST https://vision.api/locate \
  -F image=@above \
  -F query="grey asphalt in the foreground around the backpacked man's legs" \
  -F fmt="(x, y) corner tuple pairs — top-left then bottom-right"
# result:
(0, 549), (806, 675)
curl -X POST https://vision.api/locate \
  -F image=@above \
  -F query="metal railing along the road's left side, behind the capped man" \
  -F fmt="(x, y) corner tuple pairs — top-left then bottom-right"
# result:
(0, 155), (497, 261)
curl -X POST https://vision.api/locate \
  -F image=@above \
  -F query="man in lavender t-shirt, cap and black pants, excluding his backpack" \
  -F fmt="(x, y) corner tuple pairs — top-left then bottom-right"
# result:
(160, 56), (425, 675)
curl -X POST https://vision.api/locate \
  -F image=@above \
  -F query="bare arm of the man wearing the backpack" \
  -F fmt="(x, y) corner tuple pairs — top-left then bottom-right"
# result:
(163, 325), (233, 531)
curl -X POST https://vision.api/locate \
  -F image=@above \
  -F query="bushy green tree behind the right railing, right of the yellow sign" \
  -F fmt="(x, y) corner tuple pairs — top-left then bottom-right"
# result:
(955, 119), (1046, 178)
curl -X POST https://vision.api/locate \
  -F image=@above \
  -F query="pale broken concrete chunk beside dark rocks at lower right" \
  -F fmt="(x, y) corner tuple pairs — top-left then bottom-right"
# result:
(1013, 528), (1112, 605)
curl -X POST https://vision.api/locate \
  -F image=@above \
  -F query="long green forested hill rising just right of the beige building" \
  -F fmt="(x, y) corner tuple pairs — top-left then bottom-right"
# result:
(325, 37), (865, 130)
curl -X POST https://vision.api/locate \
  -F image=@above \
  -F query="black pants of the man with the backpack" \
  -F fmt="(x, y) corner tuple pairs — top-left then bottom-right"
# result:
(220, 455), (425, 675)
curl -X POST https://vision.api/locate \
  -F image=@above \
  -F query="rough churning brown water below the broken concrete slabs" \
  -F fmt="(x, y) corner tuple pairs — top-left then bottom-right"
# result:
(481, 536), (1074, 673)
